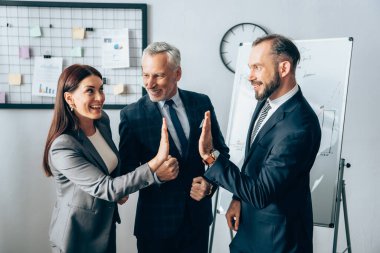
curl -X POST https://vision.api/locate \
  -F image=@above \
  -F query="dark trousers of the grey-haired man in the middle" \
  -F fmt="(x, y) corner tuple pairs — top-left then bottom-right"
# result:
(137, 215), (209, 253)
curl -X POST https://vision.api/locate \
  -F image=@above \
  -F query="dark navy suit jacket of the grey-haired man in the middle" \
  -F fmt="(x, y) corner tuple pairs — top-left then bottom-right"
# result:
(119, 89), (229, 239)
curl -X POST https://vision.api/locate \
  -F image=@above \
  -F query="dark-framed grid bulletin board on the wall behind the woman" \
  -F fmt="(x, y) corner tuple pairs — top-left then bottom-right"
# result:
(0, 1), (147, 109)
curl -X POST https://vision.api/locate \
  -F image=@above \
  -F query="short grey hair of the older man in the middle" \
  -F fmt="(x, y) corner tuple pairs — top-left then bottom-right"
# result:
(142, 42), (181, 69)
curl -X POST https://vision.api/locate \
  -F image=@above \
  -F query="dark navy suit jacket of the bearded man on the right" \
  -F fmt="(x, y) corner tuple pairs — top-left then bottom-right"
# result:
(205, 90), (321, 253)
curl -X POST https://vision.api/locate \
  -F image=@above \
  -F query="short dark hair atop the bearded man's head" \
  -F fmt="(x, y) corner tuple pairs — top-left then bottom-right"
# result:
(252, 34), (300, 71)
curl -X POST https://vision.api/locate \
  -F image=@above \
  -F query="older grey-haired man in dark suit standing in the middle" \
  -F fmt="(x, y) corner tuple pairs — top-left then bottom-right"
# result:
(119, 42), (229, 253)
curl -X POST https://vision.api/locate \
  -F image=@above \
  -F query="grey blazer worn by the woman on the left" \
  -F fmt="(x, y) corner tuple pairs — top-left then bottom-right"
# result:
(49, 112), (154, 253)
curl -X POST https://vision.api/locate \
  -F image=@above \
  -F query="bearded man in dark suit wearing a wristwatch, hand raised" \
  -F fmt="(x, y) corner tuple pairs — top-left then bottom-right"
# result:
(199, 35), (321, 253)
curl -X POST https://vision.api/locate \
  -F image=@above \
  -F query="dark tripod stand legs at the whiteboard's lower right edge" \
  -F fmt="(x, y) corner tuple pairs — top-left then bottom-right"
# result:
(333, 158), (352, 253)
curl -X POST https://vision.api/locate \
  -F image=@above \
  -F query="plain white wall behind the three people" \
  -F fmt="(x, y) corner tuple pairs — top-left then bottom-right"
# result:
(0, 0), (380, 253)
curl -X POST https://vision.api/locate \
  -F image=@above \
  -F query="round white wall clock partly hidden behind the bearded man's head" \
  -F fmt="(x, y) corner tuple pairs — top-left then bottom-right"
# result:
(219, 23), (268, 73)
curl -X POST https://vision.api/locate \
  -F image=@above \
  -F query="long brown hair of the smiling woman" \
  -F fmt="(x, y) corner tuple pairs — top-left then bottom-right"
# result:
(43, 64), (102, 177)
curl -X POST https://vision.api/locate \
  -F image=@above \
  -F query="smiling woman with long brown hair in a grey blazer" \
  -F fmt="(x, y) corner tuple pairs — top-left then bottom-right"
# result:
(43, 64), (178, 253)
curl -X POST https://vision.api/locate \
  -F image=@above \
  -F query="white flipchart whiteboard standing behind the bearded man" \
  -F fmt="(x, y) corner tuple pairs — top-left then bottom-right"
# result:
(218, 38), (352, 226)
